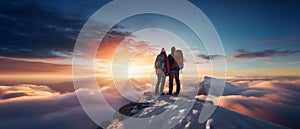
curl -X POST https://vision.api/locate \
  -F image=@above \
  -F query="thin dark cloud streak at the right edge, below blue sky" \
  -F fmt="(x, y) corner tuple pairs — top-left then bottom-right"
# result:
(233, 49), (299, 59)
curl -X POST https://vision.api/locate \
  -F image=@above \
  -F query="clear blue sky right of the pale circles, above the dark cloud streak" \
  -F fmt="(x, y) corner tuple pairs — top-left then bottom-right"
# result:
(195, 0), (300, 53)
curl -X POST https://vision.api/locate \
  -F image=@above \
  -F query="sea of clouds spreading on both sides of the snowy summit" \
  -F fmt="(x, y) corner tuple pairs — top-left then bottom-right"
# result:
(0, 76), (300, 129)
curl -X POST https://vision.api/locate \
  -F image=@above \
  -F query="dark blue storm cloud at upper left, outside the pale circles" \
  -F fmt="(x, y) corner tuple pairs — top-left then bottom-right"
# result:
(0, 1), (110, 58)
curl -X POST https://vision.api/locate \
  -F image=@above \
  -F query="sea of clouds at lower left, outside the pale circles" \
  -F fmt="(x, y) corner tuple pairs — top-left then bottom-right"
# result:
(0, 84), (118, 129)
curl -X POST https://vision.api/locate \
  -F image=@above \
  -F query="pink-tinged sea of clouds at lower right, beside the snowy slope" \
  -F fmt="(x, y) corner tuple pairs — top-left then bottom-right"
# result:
(220, 77), (300, 128)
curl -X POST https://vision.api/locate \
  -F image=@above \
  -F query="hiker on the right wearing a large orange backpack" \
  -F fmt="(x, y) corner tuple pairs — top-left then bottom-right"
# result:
(168, 46), (183, 95)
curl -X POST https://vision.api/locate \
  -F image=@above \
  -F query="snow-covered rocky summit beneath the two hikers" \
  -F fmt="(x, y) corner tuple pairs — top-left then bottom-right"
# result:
(104, 94), (285, 129)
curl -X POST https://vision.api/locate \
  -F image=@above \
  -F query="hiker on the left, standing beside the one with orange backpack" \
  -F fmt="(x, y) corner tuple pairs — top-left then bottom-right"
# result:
(155, 48), (170, 95)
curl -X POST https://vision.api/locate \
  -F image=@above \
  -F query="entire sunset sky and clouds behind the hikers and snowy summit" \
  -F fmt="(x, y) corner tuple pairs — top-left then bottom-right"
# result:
(0, 0), (300, 129)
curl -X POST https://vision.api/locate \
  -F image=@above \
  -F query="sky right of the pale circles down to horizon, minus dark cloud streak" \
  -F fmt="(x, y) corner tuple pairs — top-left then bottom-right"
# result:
(192, 0), (300, 75)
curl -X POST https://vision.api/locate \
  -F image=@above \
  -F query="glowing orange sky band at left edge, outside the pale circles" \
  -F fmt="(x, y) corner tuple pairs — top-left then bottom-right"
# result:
(0, 58), (72, 83)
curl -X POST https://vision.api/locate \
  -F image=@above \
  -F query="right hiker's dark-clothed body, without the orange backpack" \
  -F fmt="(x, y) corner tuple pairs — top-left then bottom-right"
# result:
(168, 47), (180, 94)
